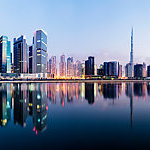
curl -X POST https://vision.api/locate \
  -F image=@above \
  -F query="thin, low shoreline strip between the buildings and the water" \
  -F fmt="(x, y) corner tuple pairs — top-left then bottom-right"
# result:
(0, 79), (150, 83)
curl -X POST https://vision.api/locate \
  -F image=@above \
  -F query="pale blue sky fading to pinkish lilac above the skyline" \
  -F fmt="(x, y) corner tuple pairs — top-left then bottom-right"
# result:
(0, 0), (150, 65)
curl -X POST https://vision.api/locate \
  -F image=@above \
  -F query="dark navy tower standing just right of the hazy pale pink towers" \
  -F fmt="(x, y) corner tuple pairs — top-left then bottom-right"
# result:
(85, 56), (94, 76)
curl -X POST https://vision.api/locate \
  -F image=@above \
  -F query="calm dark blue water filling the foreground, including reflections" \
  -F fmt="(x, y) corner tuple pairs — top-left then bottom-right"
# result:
(0, 83), (150, 150)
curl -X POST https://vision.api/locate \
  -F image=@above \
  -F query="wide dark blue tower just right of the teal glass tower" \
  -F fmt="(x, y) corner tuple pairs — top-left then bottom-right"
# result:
(14, 36), (29, 73)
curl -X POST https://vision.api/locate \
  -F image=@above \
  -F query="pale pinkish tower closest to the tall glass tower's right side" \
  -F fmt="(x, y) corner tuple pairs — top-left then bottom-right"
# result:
(49, 56), (57, 78)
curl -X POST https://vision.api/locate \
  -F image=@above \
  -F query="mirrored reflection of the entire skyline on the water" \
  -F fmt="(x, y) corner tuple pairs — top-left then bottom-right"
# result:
(0, 82), (150, 134)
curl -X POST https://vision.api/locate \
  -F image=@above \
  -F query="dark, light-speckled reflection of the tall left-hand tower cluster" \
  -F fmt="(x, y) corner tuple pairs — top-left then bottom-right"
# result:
(0, 83), (48, 134)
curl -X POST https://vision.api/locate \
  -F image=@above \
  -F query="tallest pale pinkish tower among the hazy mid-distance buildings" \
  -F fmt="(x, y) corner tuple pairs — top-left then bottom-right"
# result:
(59, 55), (66, 77)
